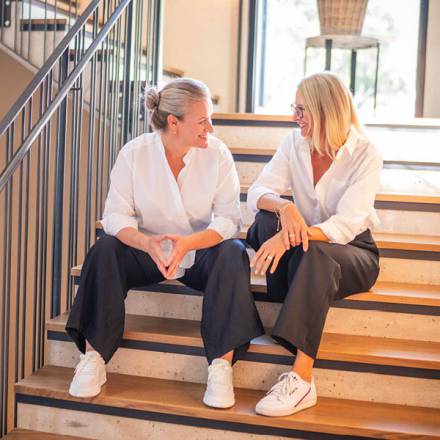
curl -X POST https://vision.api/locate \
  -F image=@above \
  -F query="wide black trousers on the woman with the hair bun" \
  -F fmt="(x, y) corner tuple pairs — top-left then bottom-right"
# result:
(66, 235), (264, 363)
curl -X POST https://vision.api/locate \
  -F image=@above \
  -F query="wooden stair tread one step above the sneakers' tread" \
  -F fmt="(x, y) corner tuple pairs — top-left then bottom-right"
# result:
(47, 313), (440, 370)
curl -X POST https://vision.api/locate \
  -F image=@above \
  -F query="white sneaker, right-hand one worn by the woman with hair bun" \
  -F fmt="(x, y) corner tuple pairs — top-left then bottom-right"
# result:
(203, 359), (235, 408)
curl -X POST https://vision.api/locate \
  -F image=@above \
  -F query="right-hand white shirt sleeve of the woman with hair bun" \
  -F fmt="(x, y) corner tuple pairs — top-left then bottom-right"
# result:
(208, 146), (242, 240)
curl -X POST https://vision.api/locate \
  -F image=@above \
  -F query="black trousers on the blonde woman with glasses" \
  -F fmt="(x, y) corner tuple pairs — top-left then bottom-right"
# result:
(246, 211), (379, 358)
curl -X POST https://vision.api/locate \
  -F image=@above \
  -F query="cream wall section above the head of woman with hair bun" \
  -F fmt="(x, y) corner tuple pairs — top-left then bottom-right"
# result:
(163, 0), (239, 112)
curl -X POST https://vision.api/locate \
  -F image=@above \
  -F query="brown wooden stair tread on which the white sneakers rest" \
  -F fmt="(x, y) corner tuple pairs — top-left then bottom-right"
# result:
(15, 366), (440, 438)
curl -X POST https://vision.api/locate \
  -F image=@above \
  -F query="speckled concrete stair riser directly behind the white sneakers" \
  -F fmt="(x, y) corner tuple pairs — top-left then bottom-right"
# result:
(48, 340), (440, 408)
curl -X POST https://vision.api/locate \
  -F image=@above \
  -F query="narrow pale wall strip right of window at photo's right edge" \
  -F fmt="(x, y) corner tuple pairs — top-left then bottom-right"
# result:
(423, 0), (440, 118)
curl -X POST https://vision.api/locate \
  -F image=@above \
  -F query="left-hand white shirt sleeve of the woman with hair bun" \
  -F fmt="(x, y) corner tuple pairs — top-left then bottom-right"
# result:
(102, 150), (138, 235)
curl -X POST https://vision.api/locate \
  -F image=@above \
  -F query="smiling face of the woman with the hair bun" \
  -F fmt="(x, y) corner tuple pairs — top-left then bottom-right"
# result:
(176, 100), (214, 148)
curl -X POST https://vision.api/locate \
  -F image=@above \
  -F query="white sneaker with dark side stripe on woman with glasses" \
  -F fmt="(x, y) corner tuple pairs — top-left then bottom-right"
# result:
(255, 371), (317, 416)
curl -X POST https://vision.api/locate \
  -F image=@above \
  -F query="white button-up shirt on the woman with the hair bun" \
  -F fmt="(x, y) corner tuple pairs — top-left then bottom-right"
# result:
(102, 133), (241, 268)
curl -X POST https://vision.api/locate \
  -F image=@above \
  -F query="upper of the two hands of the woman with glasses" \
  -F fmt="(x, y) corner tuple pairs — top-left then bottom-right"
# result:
(278, 203), (309, 252)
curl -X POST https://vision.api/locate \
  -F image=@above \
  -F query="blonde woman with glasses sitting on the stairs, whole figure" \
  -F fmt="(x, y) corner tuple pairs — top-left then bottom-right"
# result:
(247, 73), (382, 416)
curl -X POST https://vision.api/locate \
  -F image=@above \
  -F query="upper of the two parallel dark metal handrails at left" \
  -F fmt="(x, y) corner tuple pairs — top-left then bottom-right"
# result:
(0, 0), (100, 136)
